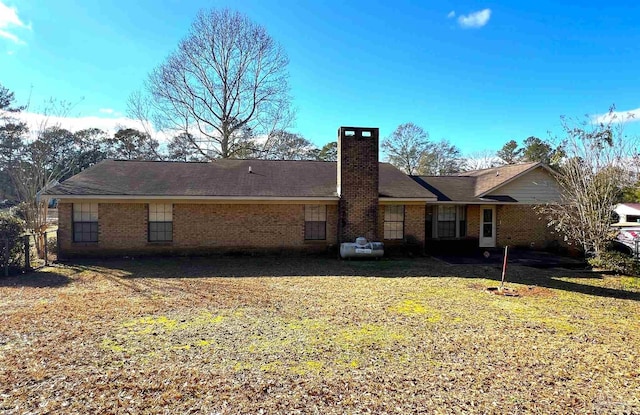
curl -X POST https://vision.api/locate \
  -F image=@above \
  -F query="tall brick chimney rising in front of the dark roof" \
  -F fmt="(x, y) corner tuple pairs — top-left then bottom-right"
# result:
(337, 127), (379, 242)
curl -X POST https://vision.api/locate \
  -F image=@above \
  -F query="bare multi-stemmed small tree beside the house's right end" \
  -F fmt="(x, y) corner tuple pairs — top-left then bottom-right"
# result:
(540, 109), (638, 257)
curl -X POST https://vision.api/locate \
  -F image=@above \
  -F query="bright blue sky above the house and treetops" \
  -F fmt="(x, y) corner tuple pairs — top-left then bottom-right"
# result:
(0, 0), (640, 153)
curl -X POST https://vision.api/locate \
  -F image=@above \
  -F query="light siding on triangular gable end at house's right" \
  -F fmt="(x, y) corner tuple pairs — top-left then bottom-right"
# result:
(489, 167), (560, 204)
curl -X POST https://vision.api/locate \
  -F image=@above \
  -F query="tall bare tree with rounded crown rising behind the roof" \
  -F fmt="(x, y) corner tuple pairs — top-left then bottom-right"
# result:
(139, 9), (291, 159)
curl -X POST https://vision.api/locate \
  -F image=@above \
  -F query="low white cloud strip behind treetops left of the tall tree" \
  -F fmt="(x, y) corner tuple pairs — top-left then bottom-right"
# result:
(16, 112), (168, 143)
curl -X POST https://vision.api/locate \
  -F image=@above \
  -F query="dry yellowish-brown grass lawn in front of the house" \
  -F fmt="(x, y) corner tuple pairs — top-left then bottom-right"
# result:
(0, 257), (640, 414)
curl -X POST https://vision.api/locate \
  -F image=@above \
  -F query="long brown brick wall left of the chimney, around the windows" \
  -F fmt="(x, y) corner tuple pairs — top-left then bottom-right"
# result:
(58, 203), (338, 257)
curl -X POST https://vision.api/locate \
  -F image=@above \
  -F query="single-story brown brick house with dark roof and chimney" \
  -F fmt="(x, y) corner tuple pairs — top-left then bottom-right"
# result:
(46, 127), (559, 257)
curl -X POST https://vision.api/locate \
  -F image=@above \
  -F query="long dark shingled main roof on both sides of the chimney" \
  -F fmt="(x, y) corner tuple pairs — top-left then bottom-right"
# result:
(46, 160), (436, 200)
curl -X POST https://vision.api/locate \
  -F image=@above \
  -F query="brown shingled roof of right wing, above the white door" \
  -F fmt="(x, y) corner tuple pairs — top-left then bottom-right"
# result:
(411, 163), (548, 203)
